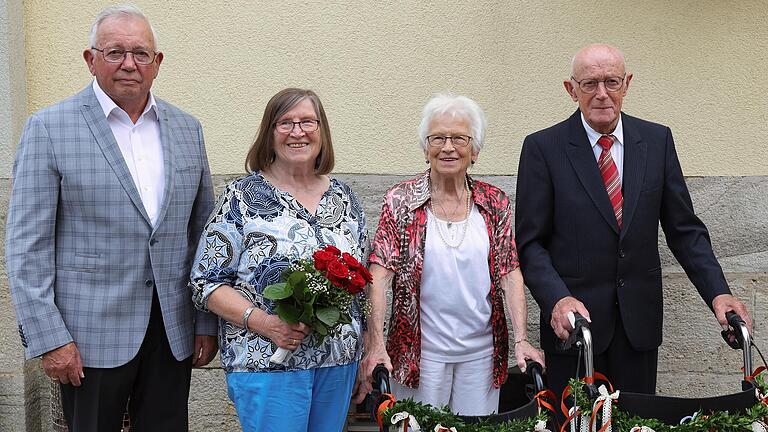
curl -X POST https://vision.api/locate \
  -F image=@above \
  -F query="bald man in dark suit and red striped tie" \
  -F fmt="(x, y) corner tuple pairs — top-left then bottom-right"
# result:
(515, 44), (751, 393)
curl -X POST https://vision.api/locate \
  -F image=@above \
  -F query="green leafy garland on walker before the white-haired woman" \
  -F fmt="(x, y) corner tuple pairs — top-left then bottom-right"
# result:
(383, 398), (547, 432)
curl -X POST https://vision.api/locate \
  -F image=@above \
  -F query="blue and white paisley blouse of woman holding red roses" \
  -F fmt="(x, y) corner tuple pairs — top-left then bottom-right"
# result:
(190, 172), (367, 372)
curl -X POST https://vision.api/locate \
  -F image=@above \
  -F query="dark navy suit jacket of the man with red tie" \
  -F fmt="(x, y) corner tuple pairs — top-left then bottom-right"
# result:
(515, 110), (730, 354)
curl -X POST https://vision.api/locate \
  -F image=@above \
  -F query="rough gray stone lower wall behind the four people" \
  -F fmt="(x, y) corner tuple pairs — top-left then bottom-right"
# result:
(0, 175), (768, 431)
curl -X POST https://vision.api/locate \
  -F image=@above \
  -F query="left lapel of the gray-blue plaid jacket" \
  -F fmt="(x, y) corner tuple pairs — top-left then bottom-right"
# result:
(80, 86), (152, 225)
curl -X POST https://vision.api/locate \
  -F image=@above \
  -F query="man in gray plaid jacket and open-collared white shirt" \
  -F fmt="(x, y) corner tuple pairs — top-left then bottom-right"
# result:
(6, 6), (217, 432)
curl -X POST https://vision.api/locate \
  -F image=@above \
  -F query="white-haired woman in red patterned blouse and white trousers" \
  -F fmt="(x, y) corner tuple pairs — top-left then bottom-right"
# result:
(357, 95), (544, 415)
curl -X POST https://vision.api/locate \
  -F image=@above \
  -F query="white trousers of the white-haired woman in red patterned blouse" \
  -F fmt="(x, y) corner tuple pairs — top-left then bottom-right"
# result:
(392, 356), (499, 415)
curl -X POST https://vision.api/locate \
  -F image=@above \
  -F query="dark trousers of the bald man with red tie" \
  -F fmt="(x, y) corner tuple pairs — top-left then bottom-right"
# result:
(545, 319), (659, 406)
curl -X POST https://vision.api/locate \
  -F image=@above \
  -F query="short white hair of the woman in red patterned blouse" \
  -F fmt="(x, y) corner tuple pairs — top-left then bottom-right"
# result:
(419, 93), (487, 153)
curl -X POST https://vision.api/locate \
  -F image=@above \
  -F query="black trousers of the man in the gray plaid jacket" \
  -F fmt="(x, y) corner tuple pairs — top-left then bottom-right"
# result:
(61, 293), (192, 432)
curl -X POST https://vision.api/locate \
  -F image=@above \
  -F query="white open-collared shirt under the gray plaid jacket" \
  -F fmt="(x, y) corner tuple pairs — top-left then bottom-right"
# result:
(93, 80), (165, 225)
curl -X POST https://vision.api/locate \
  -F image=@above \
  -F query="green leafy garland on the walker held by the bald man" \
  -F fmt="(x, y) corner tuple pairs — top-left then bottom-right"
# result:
(568, 375), (768, 432)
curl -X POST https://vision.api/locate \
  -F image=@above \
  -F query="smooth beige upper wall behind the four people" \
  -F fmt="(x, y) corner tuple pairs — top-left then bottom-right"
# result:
(24, 0), (768, 176)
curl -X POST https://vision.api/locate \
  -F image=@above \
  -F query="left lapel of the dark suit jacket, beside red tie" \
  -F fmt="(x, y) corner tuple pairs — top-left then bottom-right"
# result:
(565, 110), (619, 234)
